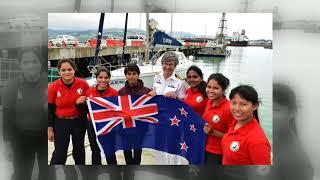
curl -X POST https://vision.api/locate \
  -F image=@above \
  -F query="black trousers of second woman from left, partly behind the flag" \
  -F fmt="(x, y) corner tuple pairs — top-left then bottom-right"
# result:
(86, 121), (117, 165)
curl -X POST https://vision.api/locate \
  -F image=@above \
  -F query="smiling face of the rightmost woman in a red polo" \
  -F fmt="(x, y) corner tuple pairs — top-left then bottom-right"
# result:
(230, 94), (258, 122)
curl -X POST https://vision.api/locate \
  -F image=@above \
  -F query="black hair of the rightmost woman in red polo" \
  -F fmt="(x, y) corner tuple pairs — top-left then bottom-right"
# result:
(229, 85), (259, 122)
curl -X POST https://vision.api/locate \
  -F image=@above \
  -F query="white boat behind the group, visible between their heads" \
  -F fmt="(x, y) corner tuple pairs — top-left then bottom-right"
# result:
(87, 51), (193, 90)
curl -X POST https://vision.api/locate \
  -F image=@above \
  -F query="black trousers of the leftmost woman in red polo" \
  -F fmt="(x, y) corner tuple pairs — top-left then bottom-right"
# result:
(50, 118), (86, 165)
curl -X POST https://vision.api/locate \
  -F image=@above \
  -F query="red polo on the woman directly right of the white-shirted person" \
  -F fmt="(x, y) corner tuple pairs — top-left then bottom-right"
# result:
(184, 88), (208, 116)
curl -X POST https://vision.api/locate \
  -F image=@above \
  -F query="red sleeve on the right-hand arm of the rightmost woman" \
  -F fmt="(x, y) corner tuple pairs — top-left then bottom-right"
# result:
(248, 140), (271, 165)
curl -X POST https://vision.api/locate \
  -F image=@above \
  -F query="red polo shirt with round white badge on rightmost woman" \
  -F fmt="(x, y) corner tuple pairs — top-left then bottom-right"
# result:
(221, 118), (271, 165)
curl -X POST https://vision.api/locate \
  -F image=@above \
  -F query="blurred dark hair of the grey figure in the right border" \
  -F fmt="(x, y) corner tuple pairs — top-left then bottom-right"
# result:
(273, 82), (297, 134)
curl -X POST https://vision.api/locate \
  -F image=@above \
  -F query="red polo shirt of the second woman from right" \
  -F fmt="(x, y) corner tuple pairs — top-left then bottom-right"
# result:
(202, 98), (233, 154)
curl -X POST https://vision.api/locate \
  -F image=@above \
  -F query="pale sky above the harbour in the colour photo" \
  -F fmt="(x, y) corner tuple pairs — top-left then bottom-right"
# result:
(48, 13), (272, 40)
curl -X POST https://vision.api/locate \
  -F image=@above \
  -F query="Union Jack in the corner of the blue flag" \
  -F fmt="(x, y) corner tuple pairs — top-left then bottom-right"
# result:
(88, 95), (159, 136)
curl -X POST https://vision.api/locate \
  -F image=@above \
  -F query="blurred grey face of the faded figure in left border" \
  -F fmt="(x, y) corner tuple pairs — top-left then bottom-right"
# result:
(20, 51), (41, 81)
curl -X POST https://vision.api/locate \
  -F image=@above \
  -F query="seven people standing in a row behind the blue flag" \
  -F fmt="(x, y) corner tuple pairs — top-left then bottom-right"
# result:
(48, 51), (271, 165)
